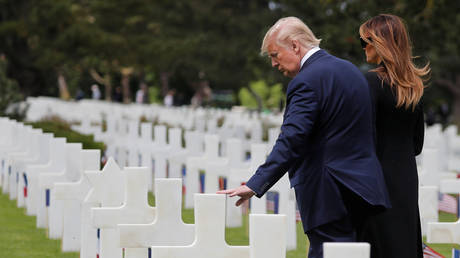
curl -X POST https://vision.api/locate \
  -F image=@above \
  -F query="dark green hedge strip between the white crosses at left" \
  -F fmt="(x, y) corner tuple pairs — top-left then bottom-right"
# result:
(28, 117), (106, 153)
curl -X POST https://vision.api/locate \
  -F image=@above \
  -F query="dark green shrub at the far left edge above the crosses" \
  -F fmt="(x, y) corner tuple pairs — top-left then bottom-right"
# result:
(0, 55), (22, 116)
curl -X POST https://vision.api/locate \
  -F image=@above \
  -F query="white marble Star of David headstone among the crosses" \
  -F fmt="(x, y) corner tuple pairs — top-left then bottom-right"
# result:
(85, 158), (125, 258)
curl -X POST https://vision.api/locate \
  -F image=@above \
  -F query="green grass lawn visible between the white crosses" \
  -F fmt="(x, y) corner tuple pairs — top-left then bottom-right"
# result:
(0, 189), (459, 258)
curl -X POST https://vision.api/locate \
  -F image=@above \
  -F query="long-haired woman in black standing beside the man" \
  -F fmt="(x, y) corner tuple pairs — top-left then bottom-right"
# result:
(359, 14), (430, 258)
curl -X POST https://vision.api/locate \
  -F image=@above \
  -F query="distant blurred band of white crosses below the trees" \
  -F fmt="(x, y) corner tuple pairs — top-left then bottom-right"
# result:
(23, 97), (282, 142)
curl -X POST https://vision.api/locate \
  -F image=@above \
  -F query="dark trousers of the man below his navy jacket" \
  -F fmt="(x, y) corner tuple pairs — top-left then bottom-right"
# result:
(307, 181), (384, 258)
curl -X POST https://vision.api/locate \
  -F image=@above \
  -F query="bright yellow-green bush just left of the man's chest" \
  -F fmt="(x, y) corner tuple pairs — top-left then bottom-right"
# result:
(238, 80), (285, 109)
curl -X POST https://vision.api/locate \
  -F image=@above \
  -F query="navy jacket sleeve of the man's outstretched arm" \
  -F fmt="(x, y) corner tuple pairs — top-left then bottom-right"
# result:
(246, 81), (318, 197)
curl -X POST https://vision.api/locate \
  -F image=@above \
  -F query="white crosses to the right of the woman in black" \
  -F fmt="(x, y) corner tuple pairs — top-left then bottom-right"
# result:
(418, 124), (460, 244)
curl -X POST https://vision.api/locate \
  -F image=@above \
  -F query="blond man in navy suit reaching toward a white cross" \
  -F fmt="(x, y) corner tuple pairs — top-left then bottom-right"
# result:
(218, 17), (390, 258)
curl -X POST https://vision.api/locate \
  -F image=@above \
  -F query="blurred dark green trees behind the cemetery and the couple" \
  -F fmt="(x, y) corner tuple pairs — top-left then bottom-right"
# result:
(0, 0), (460, 124)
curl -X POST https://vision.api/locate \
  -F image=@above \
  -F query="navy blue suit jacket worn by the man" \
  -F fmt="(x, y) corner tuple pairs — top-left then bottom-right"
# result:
(246, 50), (390, 232)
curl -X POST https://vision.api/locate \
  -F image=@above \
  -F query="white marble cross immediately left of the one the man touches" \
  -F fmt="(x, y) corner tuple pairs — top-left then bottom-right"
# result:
(118, 178), (195, 248)
